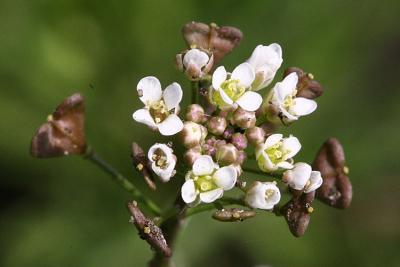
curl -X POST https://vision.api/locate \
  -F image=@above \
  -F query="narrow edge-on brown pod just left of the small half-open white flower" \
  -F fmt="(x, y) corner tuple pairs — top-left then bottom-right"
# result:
(132, 142), (157, 190)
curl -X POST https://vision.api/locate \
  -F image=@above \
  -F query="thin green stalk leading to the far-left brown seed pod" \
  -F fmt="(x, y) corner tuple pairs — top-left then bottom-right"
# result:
(84, 147), (161, 216)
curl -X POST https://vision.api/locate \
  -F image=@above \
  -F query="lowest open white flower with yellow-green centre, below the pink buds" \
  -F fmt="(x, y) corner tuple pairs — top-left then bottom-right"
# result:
(181, 155), (237, 203)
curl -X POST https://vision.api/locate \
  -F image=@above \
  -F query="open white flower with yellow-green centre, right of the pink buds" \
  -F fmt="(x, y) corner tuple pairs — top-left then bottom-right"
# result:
(256, 134), (301, 172)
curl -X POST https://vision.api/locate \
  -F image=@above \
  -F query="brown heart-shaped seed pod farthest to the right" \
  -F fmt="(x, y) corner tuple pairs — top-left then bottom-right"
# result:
(313, 138), (353, 209)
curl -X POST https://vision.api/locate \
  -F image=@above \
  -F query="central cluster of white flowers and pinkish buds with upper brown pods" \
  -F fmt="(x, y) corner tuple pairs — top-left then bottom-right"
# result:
(127, 22), (346, 238)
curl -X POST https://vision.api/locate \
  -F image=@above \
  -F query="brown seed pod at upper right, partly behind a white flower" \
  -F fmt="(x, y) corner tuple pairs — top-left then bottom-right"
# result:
(283, 67), (324, 99)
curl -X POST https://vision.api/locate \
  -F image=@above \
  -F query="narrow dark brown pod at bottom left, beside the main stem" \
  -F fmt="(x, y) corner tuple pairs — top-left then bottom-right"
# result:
(127, 201), (172, 257)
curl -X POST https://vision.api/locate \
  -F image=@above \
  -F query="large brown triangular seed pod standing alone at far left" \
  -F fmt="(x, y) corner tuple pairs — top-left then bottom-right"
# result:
(30, 93), (86, 158)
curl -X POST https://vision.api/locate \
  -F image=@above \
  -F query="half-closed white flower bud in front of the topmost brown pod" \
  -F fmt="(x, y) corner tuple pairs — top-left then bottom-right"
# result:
(176, 48), (214, 80)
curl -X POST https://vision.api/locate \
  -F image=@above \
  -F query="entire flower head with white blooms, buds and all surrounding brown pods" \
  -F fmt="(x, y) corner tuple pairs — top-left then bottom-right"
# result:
(31, 22), (352, 262)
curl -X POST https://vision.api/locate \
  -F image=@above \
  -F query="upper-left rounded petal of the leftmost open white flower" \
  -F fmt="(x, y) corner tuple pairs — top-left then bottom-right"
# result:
(136, 76), (162, 105)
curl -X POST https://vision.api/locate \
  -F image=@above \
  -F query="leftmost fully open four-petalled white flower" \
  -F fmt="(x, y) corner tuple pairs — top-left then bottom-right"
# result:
(133, 76), (183, 135)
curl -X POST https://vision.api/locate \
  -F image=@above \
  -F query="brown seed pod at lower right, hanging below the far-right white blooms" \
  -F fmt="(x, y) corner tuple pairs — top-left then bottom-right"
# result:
(279, 191), (315, 237)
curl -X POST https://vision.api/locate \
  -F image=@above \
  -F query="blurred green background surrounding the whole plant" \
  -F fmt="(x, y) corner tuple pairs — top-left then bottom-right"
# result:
(0, 0), (400, 267)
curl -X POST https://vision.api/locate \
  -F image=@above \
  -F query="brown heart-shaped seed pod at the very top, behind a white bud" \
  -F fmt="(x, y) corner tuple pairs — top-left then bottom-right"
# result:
(182, 21), (243, 66)
